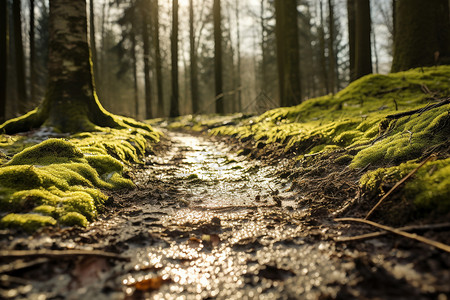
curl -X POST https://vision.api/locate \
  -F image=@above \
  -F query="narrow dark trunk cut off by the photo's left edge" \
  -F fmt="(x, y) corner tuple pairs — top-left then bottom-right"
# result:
(0, 1), (8, 123)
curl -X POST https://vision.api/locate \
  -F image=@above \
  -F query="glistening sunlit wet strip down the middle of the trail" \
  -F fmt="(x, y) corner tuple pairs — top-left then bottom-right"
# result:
(123, 133), (346, 299)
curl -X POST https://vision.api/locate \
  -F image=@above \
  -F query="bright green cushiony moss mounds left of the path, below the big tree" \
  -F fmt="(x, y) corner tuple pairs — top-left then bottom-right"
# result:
(0, 124), (159, 232)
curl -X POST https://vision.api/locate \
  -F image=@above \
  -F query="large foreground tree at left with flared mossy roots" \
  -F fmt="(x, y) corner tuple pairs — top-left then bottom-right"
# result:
(0, 0), (150, 134)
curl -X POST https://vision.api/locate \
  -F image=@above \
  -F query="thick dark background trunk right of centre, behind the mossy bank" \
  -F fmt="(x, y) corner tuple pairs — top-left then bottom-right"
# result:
(275, 0), (302, 106)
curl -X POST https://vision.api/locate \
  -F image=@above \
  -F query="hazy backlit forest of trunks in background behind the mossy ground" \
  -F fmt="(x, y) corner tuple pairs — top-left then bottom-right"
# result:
(0, 0), (450, 121)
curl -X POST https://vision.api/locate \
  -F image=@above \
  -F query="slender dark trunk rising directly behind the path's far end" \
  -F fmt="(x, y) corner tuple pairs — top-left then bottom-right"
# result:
(170, 0), (180, 118)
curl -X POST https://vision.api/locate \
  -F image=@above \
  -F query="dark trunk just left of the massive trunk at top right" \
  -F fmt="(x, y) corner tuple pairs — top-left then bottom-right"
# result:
(355, 0), (372, 79)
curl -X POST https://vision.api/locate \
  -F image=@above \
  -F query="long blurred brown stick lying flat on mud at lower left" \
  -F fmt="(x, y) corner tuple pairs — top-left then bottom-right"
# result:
(0, 250), (130, 261)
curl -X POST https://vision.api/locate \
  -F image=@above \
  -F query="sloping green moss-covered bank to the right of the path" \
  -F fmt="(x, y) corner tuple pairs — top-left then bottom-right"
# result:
(171, 66), (450, 224)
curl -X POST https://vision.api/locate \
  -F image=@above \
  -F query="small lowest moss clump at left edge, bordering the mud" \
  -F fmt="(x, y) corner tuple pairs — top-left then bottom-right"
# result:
(0, 214), (56, 232)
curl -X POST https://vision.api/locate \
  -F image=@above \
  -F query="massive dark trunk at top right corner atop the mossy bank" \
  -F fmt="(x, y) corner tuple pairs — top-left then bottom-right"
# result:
(391, 0), (450, 72)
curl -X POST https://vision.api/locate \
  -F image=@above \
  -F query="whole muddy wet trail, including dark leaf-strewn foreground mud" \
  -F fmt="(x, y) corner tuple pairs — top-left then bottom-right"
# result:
(0, 132), (450, 300)
